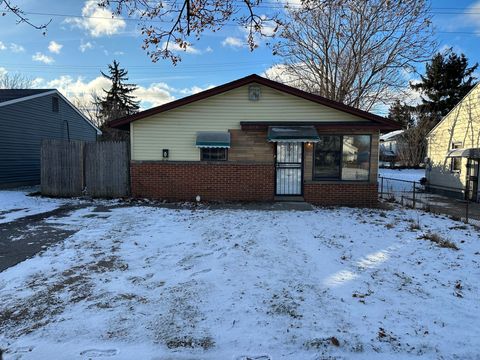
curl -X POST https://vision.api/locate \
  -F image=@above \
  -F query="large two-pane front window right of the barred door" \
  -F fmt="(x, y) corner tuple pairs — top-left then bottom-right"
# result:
(313, 135), (371, 181)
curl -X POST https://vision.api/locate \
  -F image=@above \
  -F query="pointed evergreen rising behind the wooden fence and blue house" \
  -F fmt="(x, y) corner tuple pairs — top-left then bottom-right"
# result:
(99, 60), (139, 122)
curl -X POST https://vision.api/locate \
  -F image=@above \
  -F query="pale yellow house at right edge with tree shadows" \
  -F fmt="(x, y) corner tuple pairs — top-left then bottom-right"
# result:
(426, 84), (480, 201)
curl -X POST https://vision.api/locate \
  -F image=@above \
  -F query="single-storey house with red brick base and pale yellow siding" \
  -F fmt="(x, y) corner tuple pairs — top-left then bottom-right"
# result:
(110, 75), (399, 206)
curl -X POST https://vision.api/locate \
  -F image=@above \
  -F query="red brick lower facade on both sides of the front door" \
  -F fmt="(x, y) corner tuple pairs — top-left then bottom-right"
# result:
(131, 161), (378, 207)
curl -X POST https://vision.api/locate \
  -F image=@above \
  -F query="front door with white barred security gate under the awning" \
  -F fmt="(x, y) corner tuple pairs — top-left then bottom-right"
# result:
(275, 142), (303, 196)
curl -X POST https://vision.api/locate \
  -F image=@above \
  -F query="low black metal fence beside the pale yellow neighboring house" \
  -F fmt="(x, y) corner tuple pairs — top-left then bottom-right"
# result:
(378, 176), (480, 227)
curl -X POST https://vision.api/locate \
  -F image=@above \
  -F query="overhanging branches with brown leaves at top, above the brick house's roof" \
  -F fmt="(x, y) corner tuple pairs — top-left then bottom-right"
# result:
(98, 0), (282, 64)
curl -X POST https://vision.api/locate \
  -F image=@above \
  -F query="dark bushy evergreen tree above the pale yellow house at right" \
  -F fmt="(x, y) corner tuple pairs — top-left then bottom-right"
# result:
(410, 49), (478, 128)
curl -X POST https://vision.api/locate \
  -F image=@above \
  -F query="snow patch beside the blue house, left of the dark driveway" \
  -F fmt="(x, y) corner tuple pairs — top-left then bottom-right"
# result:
(0, 188), (66, 224)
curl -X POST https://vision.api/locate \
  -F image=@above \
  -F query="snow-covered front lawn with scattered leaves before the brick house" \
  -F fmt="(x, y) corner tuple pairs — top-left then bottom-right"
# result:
(0, 206), (480, 360)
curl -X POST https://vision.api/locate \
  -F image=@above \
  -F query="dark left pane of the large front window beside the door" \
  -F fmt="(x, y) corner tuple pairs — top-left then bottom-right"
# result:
(313, 135), (342, 179)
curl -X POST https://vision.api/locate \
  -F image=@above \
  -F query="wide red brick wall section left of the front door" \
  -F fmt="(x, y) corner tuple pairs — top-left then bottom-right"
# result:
(131, 161), (275, 201)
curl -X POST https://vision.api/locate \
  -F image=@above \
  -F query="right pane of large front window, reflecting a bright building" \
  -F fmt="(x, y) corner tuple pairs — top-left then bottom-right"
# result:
(342, 135), (370, 181)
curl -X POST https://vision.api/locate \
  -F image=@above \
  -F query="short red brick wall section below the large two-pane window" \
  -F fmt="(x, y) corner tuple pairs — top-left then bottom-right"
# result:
(304, 182), (378, 207)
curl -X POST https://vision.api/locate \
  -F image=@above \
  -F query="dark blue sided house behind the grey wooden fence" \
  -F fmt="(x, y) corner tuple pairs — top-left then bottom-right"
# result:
(0, 89), (101, 187)
